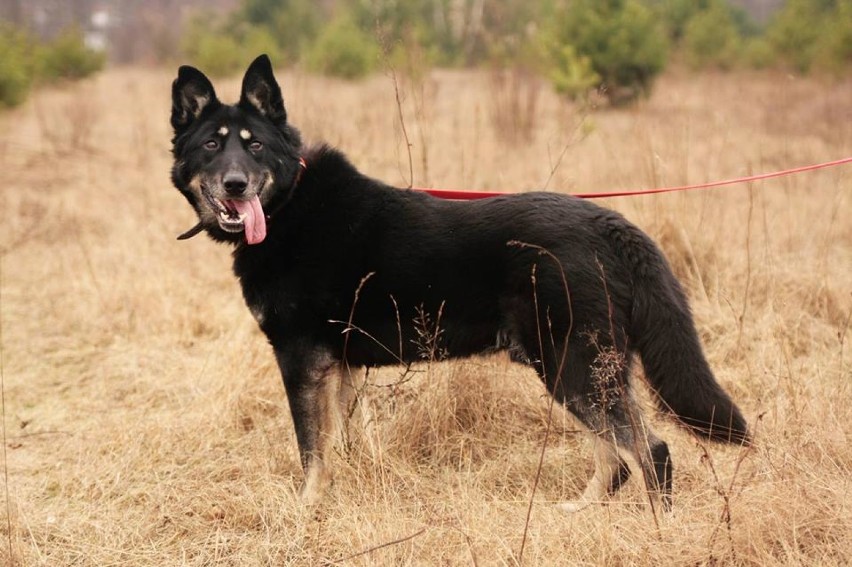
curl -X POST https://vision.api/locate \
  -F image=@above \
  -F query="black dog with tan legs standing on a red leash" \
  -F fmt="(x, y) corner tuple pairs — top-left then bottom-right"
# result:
(171, 56), (749, 510)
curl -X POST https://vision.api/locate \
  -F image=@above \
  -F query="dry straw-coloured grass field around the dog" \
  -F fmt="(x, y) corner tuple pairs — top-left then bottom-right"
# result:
(0, 64), (852, 566)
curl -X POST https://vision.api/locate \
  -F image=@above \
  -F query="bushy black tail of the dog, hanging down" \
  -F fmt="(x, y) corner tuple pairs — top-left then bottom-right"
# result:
(610, 223), (751, 444)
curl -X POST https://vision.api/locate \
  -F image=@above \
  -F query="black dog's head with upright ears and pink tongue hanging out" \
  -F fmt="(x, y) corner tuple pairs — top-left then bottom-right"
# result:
(171, 55), (301, 244)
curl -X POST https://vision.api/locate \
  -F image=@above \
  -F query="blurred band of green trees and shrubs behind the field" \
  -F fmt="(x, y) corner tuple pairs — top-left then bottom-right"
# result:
(0, 0), (852, 105)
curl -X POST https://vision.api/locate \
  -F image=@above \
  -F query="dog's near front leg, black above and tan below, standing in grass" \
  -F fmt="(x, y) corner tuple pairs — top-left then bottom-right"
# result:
(275, 349), (340, 505)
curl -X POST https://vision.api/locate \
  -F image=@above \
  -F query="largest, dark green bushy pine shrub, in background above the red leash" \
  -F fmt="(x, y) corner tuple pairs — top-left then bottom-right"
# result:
(554, 0), (667, 104)
